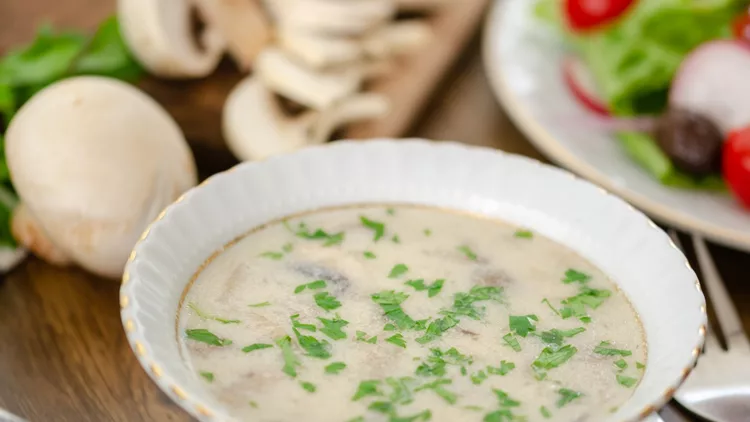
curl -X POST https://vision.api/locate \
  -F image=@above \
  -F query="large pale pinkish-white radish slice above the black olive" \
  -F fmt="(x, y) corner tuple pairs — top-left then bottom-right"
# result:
(669, 41), (750, 135)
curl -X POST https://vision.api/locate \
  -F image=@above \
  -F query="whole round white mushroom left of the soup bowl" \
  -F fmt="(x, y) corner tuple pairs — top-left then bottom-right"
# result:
(6, 76), (197, 277)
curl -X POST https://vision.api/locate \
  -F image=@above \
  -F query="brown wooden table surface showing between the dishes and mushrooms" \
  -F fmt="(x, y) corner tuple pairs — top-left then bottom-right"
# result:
(0, 0), (750, 422)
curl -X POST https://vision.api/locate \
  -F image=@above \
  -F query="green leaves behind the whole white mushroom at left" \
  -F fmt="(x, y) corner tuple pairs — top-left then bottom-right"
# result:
(0, 17), (143, 247)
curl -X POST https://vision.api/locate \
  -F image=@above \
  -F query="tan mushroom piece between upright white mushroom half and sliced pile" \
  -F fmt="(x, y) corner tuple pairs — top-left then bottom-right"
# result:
(194, 0), (271, 70)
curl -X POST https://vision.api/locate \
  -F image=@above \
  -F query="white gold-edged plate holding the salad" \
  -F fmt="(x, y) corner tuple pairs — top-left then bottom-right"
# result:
(484, 0), (750, 251)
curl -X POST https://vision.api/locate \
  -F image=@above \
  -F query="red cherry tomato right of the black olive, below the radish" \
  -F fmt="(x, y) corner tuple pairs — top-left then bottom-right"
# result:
(722, 127), (750, 209)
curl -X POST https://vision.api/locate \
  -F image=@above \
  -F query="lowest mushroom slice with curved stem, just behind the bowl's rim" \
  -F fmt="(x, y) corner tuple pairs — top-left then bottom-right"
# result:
(222, 76), (388, 160)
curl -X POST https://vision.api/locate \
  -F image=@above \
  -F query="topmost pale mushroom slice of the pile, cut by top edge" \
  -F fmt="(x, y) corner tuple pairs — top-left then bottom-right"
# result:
(266, 0), (396, 35)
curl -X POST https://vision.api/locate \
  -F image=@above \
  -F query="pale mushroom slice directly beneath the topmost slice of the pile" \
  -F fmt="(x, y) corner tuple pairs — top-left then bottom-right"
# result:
(278, 28), (363, 69)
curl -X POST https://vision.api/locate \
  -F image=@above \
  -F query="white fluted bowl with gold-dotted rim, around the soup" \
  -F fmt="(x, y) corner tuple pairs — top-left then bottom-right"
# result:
(120, 140), (706, 422)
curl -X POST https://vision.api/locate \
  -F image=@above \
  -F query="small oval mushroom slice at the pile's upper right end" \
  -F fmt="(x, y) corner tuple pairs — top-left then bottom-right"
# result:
(363, 20), (432, 58)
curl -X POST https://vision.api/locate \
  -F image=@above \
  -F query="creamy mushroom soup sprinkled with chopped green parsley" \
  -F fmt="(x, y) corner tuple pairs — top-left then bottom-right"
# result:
(178, 206), (647, 422)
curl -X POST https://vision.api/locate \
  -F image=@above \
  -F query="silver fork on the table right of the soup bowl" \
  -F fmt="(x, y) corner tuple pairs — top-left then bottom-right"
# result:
(669, 230), (750, 422)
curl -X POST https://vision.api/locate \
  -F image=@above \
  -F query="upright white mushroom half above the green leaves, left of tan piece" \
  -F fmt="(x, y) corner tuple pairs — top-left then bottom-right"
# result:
(117, 0), (226, 78)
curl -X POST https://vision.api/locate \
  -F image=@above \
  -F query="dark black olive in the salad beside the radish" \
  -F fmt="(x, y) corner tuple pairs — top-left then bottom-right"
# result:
(654, 109), (724, 176)
